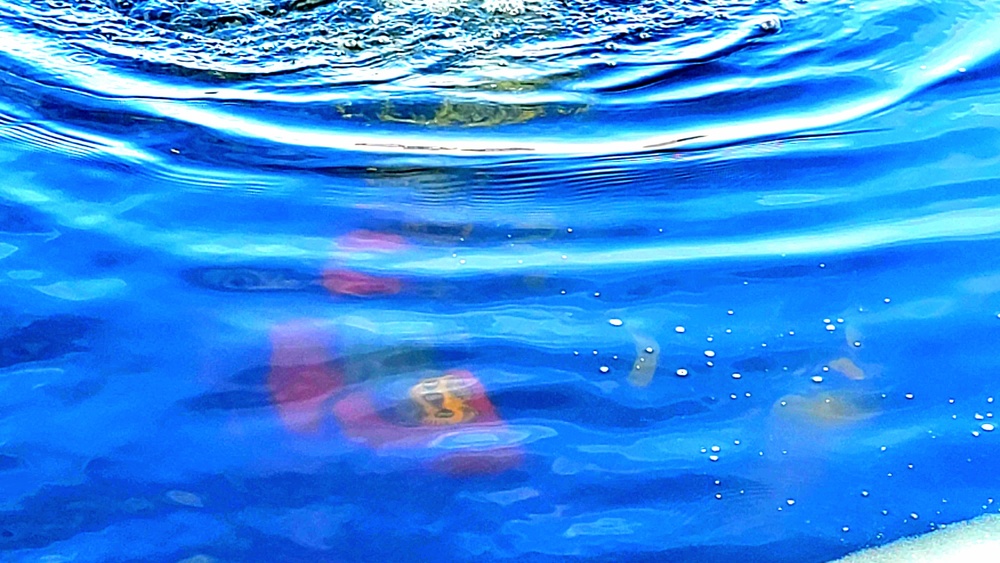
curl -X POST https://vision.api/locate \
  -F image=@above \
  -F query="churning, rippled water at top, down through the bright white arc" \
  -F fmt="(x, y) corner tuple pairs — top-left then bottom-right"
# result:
(0, 1), (1000, 158)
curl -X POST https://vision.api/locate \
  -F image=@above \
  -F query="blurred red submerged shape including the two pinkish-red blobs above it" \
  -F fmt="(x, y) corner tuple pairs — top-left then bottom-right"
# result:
(267, 226), (564, 474)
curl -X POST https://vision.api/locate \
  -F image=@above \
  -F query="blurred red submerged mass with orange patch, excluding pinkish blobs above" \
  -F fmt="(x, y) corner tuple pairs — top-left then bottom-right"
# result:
(267, 323), (523, 474)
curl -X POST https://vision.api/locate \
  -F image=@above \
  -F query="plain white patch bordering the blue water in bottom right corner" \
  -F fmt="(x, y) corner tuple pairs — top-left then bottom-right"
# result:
(835, 514), (1000, 563)
